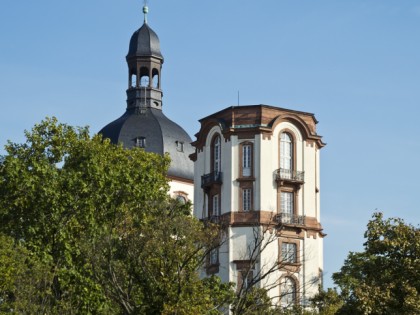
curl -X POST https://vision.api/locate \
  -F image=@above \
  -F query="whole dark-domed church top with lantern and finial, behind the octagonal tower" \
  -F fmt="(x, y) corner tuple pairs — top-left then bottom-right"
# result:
(99, 6), (194, 201)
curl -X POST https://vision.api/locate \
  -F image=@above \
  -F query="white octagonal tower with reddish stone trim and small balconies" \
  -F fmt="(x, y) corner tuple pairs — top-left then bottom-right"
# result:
(193, 105), (324, 306)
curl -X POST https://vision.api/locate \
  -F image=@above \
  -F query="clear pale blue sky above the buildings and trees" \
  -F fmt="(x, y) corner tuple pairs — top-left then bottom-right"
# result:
(0, 0), (420, 286)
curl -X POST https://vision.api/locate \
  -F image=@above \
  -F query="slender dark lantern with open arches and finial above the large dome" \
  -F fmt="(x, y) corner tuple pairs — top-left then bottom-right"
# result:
(126, 5), (163, 112)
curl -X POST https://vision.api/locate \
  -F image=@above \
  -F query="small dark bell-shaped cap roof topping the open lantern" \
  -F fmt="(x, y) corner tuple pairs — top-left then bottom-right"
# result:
(127, 23), (163, 59)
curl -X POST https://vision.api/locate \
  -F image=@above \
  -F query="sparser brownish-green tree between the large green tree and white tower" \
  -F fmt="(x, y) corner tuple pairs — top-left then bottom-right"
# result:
(92, 200), (233, 315)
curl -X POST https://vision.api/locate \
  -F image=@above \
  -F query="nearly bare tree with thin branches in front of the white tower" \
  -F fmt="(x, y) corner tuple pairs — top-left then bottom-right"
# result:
(231, 222), (319, 315)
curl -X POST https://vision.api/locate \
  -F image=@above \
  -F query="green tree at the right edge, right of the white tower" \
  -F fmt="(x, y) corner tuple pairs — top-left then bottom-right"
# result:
(333, 213), (420, 314)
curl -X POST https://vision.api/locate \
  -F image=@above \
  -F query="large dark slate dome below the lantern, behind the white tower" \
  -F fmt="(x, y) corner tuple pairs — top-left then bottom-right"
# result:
(99, 108), (194, 180)
